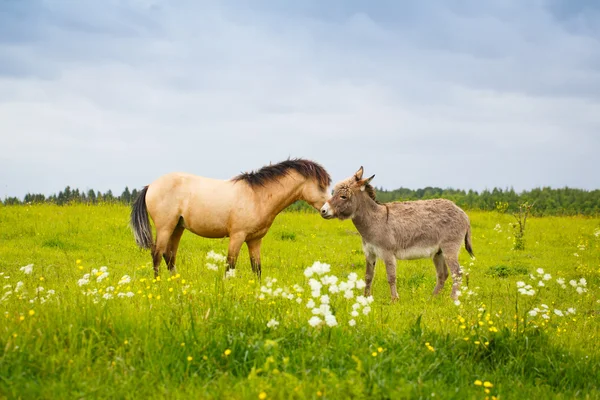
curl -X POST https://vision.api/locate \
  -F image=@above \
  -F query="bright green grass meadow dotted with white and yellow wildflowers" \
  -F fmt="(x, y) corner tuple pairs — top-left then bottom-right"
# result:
(0, 205), (600, 399)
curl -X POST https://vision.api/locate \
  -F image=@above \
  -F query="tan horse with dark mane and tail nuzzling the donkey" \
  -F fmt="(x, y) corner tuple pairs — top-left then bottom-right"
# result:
(131, 159), (331, 277)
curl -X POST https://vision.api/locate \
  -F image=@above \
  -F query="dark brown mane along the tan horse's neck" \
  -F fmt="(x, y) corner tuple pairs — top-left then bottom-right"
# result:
(232, 158), (331, 189)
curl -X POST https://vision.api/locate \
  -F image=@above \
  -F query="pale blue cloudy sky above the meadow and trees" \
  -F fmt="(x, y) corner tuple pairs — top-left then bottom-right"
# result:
(0, 0), (600, 198)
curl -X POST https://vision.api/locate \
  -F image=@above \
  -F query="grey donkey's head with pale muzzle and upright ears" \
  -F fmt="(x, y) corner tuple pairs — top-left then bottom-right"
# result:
(321, 167), (375, 219)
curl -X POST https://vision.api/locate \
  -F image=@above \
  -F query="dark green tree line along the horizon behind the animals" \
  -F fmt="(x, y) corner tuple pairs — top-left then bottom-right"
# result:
(0, 186), (600, 216)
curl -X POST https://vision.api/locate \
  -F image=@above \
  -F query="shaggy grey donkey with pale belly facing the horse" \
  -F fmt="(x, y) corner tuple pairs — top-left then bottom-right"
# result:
(321, 167), (474, 301)
